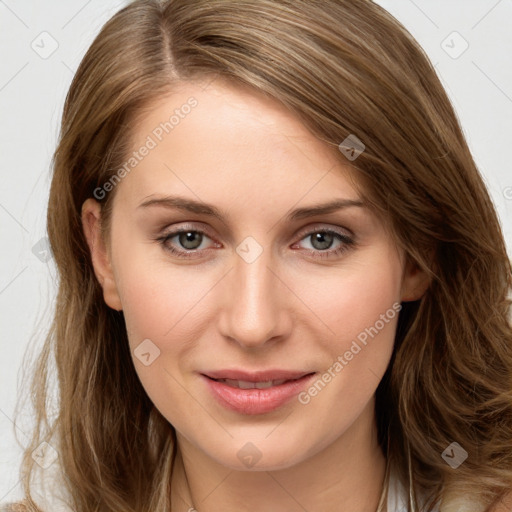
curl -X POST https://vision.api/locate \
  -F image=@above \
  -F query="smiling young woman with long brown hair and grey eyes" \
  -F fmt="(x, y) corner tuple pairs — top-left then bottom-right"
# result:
(4, 0), (512, 512)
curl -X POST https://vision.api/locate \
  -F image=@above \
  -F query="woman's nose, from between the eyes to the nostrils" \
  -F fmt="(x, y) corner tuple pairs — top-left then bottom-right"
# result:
(219, 245), (293, 348)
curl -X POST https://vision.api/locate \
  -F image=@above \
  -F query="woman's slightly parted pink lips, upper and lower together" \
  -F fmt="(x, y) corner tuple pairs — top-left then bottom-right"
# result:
(201, 370), (315, 414)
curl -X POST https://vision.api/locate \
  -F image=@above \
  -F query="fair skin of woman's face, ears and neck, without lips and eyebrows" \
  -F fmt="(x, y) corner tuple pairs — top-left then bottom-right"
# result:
(82, 80), (427, 512)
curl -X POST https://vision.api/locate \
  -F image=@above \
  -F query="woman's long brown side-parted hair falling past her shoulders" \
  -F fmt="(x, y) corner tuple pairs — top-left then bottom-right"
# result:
(11, 0), (512, 512)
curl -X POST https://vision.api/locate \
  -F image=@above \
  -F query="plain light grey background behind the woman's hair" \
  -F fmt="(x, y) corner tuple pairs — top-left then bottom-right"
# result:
(0, 0), (512, 502)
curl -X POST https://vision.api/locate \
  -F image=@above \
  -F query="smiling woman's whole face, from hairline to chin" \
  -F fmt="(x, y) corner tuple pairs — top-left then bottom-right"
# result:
(83, 80), (423, 469)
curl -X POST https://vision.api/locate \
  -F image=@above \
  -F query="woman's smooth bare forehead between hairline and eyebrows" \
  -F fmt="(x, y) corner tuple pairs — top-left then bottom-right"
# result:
(116, 79), (364, 210)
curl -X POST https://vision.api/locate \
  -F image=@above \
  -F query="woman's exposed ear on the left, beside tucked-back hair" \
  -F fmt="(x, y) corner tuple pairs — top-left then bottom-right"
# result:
(82, 198), (123, 311)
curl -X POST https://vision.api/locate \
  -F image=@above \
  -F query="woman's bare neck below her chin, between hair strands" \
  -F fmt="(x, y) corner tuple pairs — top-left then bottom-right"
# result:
(172, 402), (386, 512)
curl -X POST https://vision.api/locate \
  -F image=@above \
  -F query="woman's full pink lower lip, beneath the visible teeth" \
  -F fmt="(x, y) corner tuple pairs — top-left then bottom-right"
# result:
(201, 373), (315, 414)
